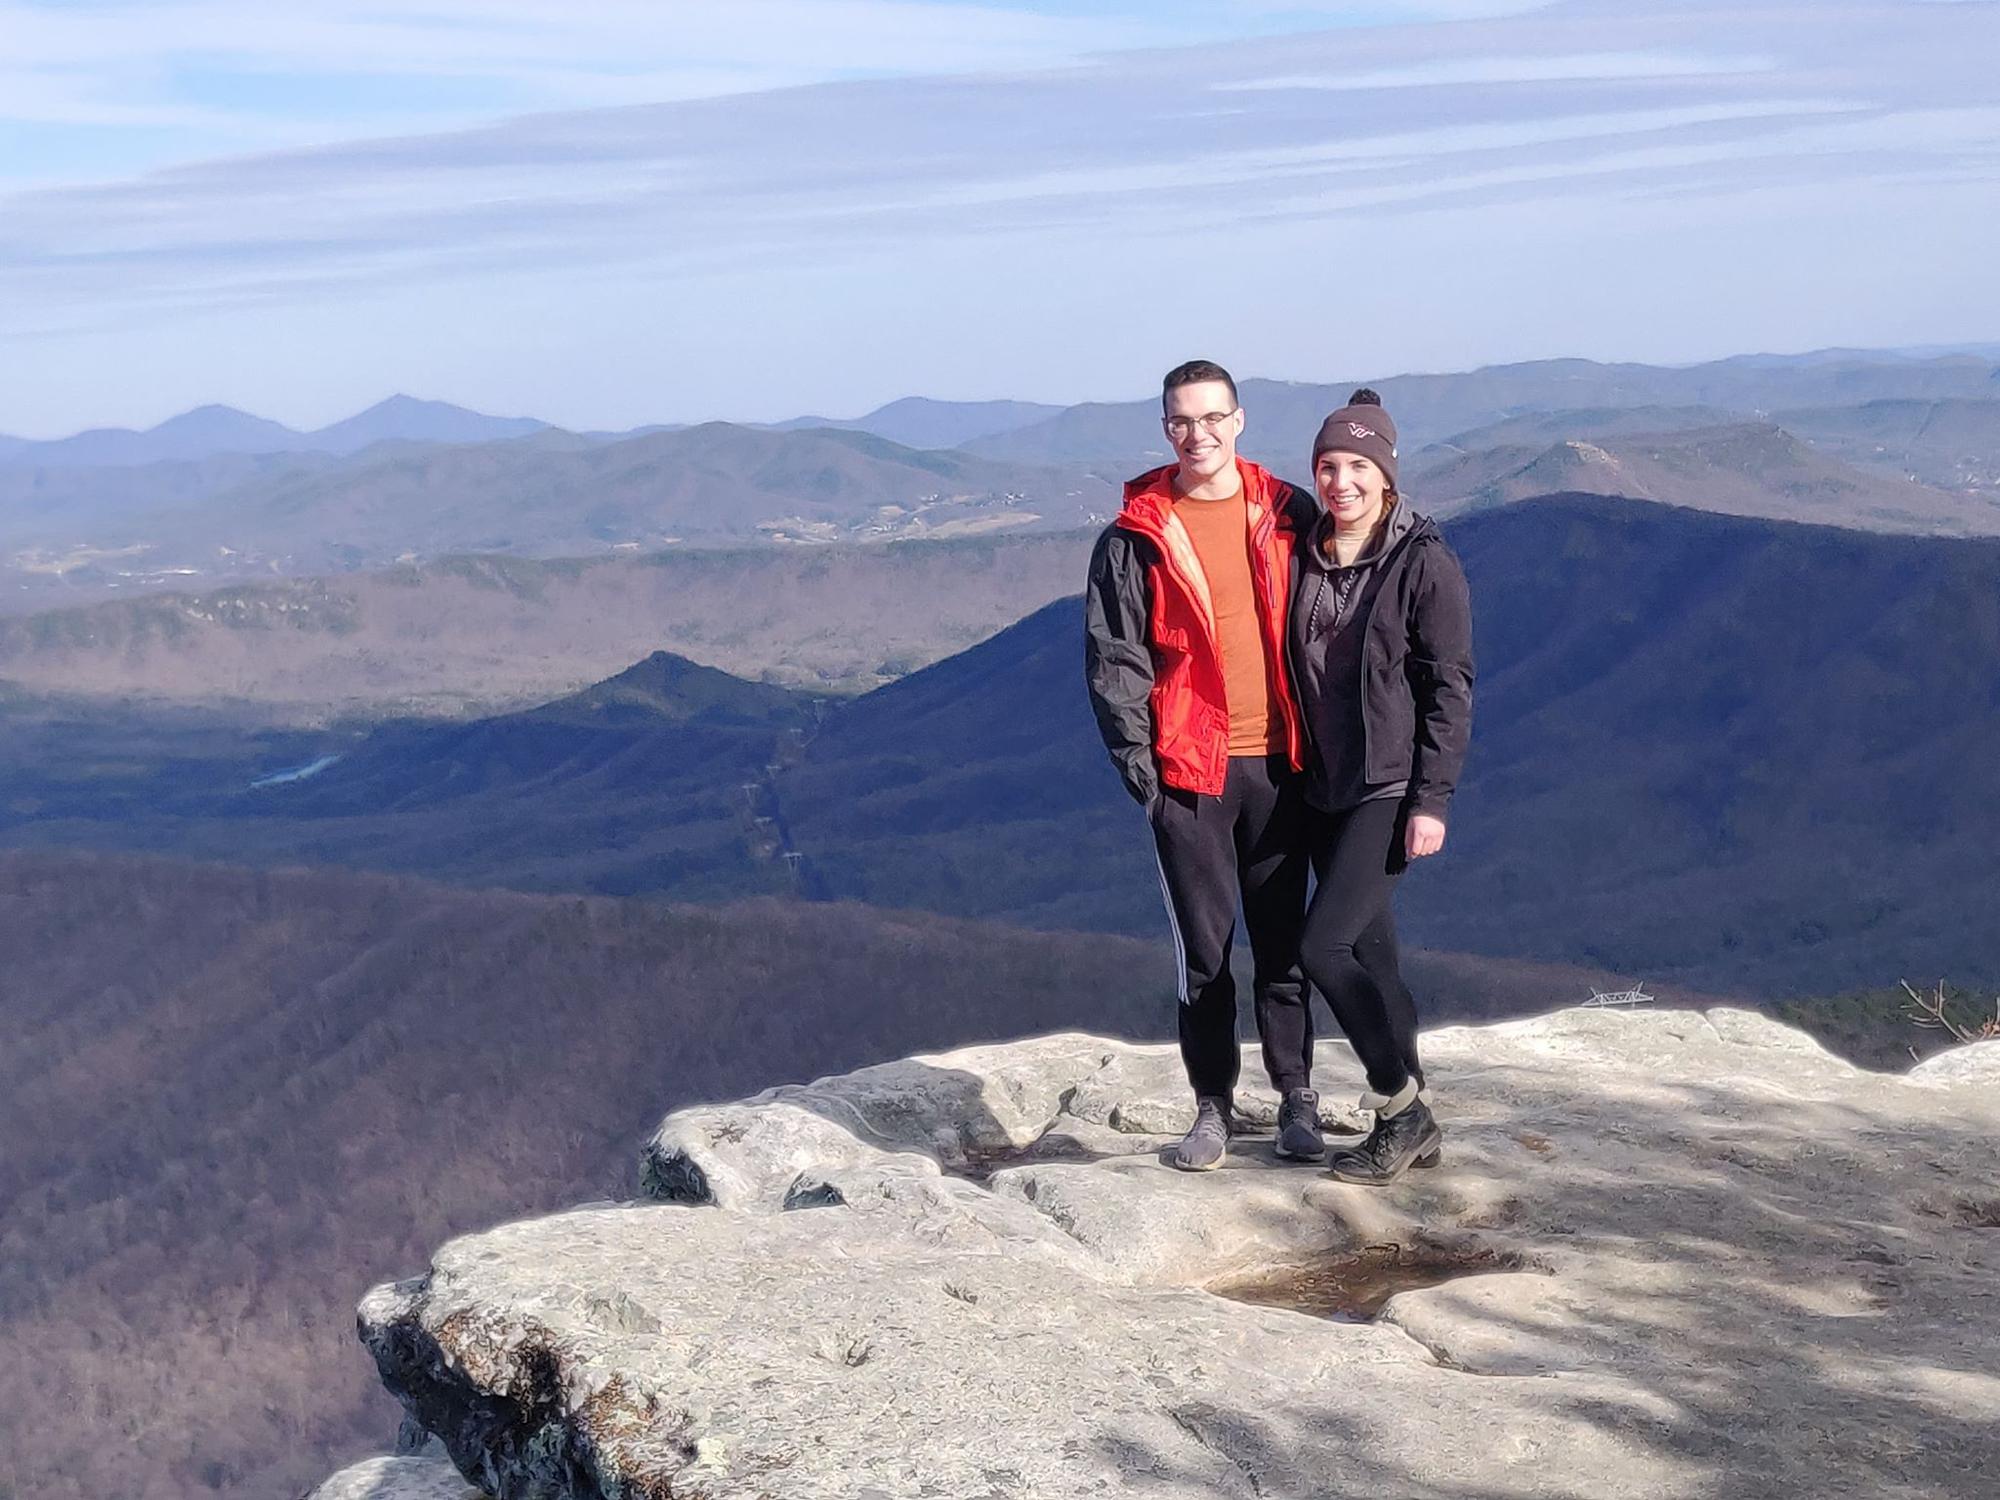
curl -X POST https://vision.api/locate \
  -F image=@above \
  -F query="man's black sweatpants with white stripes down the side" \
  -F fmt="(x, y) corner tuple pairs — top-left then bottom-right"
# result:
(1150, 756), (1312, 1094)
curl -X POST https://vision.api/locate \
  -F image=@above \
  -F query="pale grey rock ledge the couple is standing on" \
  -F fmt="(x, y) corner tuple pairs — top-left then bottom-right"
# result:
(320, 1010), (2000, 1500)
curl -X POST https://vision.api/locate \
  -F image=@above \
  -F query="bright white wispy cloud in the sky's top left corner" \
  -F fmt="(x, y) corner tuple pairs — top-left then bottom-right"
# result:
(0, 0), (1174, 182)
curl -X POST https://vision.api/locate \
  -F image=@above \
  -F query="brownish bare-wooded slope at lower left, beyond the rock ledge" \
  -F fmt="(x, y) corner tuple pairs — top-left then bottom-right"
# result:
(0, 854), (1172, 1500)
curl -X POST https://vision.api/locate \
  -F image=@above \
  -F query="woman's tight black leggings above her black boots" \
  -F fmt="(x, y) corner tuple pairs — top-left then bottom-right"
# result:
(1300, 798), (1424, 1094)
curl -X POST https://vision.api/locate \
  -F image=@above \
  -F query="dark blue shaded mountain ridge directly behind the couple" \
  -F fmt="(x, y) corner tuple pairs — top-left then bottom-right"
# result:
(782, 498), (2000, 994)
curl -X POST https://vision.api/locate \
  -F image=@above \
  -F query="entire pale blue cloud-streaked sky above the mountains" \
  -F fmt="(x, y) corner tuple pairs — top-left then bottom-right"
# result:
(0, 0), (2000, 436)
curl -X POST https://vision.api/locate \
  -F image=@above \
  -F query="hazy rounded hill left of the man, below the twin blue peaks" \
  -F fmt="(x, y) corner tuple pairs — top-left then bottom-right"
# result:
(0, 422), (1116, 578)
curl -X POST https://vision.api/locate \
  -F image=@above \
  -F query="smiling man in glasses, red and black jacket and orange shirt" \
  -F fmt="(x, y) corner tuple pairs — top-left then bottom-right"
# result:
(1084, 360), (1326, 1172)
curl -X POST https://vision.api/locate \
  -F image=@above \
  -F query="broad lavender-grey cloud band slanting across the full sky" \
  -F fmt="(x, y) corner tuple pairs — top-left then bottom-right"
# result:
(0, 0), (2000, 328)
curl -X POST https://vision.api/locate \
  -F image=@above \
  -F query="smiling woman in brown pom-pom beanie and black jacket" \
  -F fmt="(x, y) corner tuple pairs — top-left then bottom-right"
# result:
(1288, 390), (1472, 1184)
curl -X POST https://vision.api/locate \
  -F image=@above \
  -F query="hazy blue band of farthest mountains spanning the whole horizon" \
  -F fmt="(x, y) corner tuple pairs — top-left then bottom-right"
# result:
(11, 350), (2000, 614)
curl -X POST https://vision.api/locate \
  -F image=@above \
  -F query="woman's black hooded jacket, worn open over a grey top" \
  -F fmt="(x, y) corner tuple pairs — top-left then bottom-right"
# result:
(1288, 502), (1472, 818)
